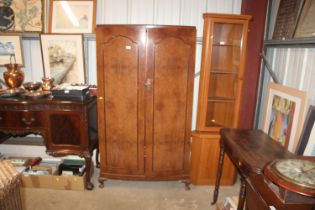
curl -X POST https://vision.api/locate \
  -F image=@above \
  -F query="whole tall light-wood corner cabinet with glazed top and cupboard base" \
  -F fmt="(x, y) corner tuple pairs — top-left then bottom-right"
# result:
(191, 14), (251, 185)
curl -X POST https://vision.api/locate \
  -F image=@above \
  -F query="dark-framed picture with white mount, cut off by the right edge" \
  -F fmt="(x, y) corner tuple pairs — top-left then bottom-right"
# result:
(296, 106), (315, 156)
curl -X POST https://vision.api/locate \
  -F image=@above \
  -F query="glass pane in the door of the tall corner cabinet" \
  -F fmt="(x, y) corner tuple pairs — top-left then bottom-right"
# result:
(206, 23), (243, 127)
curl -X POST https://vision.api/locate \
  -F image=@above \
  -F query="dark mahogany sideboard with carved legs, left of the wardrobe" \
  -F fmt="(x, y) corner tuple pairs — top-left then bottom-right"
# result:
(0, 97), (98, 190)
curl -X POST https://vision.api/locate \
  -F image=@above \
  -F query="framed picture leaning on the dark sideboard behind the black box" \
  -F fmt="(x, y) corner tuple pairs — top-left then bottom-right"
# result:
(40, 34), (85, 84)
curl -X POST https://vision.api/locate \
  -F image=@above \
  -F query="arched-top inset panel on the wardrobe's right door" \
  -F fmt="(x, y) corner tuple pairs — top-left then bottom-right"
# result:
(153, 38), (190, 171)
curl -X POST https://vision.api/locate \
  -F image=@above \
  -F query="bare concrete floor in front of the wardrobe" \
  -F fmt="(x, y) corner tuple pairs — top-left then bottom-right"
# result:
(21, 169), (239, 210)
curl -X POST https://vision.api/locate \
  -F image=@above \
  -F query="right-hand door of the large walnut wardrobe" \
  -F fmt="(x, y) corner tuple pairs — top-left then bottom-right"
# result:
(145, 27), (196, 179)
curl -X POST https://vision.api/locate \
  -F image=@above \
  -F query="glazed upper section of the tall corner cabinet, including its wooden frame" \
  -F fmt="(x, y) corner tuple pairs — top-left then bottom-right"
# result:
(197, 16), (252, 131)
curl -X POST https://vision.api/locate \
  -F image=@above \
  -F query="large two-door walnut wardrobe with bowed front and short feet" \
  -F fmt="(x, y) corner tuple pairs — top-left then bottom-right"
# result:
(96, 25), (196, 186)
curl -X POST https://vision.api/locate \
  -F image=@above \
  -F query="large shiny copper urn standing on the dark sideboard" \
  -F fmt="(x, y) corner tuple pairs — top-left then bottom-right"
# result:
(3, 63), (24, 89)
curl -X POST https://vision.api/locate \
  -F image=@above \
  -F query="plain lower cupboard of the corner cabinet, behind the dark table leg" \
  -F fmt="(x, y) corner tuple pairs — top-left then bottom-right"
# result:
(190, 133), (236, 185)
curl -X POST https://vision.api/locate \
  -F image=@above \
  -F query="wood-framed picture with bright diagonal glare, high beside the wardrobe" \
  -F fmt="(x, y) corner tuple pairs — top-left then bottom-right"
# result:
(49, 0), (96, 33)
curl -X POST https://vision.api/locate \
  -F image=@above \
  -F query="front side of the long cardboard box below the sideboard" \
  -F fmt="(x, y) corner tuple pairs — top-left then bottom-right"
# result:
(22, 174), (85, 190)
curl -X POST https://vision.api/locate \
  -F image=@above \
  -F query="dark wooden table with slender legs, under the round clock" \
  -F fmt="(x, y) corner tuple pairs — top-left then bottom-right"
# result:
(212, 128), (315, 210)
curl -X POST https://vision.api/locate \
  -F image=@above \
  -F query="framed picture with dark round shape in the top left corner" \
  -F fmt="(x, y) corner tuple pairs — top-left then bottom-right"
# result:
(0, 0), (45, 32)
